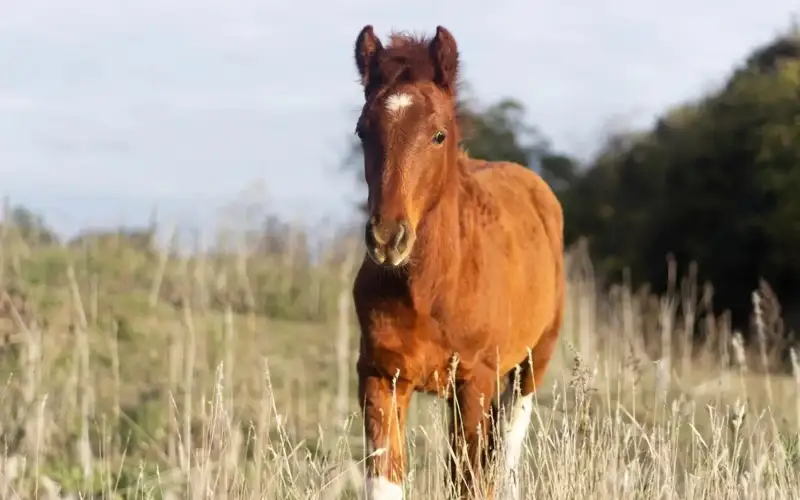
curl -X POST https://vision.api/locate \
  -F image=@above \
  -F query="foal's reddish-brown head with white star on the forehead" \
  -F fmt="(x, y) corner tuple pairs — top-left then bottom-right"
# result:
(355, 26), (459, 267)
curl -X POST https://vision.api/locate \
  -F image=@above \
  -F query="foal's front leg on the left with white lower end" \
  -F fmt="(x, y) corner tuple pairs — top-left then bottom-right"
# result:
(358, 364), (413, 500)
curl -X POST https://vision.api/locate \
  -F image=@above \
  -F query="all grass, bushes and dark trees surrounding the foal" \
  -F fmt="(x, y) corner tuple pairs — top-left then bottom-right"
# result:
(0, 24), (800, 499)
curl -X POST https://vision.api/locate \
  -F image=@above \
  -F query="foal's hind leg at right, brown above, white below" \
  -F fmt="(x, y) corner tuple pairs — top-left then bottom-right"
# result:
(497, 319), (561, 500)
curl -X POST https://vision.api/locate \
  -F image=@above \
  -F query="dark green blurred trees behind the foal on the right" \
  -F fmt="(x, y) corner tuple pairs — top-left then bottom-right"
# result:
(344, 30), (800, 338)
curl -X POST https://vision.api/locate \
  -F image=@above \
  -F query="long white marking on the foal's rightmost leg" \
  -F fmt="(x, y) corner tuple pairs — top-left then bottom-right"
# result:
(498, 390), (533, 500)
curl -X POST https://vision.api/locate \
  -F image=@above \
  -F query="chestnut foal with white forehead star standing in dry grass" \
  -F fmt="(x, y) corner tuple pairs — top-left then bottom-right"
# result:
(353, 25), (564, 500)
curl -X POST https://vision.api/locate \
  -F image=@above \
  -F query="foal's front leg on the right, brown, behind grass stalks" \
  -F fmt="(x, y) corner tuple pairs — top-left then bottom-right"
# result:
(450, 376), (495, 498)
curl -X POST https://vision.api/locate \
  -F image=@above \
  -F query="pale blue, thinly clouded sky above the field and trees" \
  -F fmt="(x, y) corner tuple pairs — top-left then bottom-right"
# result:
(0, 0), (800, 238)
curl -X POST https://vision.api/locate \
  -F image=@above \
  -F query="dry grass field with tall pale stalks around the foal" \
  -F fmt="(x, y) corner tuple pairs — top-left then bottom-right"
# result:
(0, 220), (800, 500)
